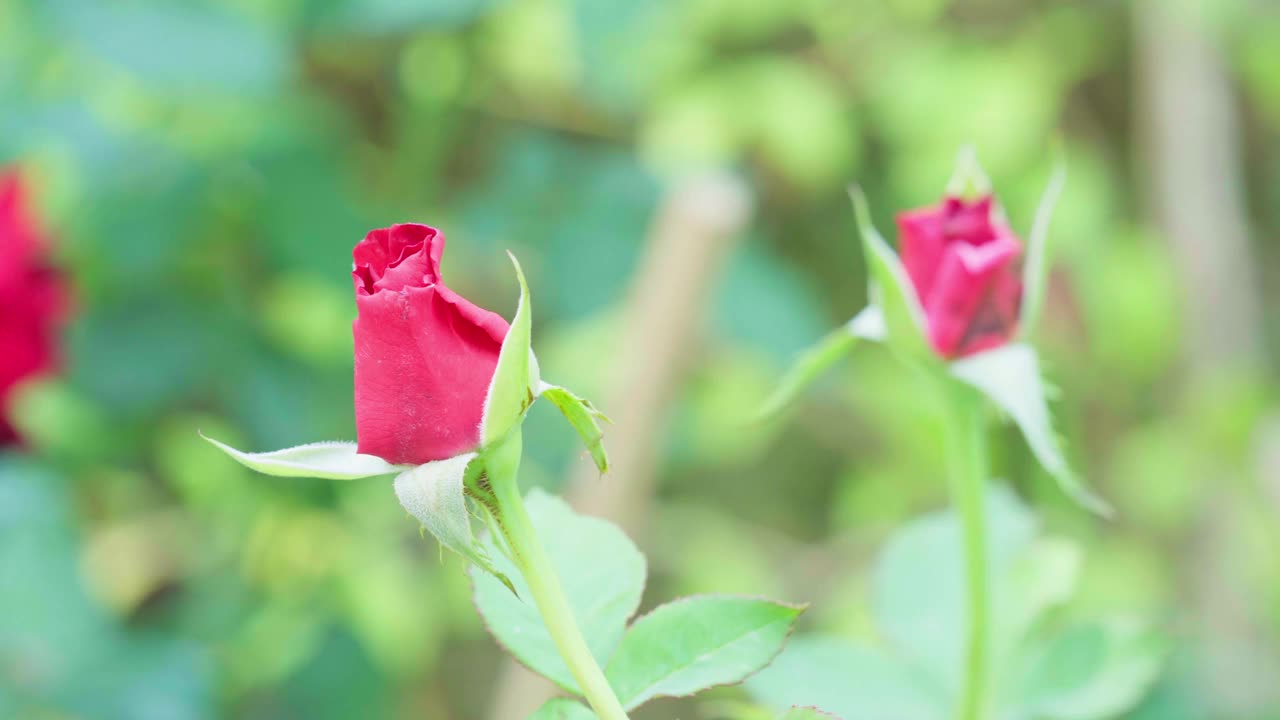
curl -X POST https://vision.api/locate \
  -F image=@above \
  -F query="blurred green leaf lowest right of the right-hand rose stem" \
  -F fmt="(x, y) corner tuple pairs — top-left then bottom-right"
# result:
(1014, 621), (1167, 720)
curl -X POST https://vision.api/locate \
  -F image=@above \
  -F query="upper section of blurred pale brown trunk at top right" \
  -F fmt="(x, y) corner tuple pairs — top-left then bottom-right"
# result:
(1134, 0), (1262, 373)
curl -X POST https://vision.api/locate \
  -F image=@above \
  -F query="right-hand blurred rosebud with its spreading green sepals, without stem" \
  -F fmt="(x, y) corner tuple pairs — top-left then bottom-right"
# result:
(760, 147), (1111, 515)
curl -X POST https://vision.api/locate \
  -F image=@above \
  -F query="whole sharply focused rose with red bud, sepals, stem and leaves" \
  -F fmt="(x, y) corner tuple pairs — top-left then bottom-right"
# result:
(210, 224), (804, 720)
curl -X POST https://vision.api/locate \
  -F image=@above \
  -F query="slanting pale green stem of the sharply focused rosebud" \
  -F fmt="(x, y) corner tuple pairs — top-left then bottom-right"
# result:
(486, 430), (628, 720)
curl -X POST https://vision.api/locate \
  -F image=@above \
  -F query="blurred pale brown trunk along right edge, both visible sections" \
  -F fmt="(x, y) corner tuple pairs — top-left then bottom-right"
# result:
(1134, 0), (1280, 716)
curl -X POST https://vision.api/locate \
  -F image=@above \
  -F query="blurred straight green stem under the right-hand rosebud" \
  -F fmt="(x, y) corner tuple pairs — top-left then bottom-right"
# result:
(946, 386), (991, 720)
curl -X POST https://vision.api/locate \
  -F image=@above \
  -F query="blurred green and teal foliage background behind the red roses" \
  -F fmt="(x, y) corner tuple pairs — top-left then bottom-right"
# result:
(0, 0), (1280, 720)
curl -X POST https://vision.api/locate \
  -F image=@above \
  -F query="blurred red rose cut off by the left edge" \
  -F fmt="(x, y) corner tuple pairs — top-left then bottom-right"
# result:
(0, 170), (67, 445)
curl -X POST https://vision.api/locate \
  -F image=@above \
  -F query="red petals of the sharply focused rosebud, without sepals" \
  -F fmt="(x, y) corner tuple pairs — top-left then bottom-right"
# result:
(351, 224), (508, 465)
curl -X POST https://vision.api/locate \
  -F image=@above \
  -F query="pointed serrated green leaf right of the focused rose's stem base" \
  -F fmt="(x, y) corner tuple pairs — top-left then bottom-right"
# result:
(604, 596), (804, 710)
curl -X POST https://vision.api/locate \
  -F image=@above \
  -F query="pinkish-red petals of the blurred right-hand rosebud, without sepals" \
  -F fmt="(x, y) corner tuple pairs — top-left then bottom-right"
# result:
(897, 195), (1023, 357)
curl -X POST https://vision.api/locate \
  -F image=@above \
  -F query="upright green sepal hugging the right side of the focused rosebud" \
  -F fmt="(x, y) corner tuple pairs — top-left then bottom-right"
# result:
(480, 252), (532, 447)
